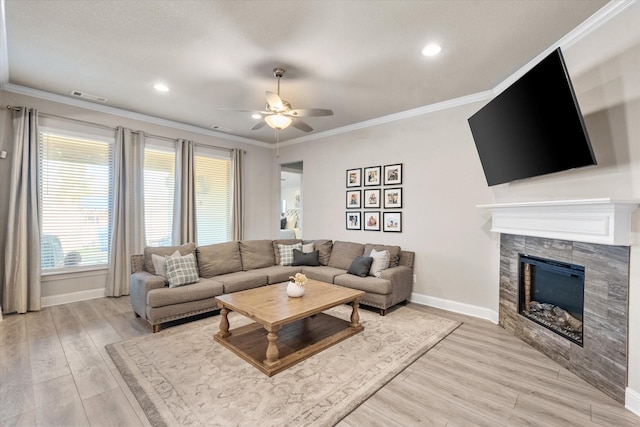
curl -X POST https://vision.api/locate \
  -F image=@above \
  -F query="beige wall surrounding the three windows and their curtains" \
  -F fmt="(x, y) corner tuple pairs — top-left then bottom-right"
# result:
(0, 91), (277, 305)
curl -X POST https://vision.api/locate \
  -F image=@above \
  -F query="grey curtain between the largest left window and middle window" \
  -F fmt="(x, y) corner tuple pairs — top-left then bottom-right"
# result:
(105, 127), (146, 296)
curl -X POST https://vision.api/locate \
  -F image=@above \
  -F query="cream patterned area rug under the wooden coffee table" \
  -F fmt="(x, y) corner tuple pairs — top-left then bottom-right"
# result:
(107, 306), (460, 426)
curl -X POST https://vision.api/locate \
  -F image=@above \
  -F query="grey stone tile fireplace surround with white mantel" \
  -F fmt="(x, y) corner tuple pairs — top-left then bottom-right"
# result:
(478, 199), (638, 404)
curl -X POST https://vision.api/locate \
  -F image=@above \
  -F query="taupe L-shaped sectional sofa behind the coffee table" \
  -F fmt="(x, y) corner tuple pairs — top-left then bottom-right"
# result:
(130, 239), (415, 332)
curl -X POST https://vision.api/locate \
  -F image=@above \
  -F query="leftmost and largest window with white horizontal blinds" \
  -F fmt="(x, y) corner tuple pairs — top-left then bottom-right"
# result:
(39, 119), (114, 271)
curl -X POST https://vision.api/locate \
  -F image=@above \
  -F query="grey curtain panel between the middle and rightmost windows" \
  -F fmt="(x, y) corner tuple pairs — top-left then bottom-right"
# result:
(172, 139), (197, 245)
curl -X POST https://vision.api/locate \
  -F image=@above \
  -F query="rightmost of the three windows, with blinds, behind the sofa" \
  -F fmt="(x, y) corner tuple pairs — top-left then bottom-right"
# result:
(194, 146), (231, 246)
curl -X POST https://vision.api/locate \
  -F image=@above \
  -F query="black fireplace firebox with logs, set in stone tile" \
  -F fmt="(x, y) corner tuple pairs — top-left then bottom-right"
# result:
(518, 254), (584, 347)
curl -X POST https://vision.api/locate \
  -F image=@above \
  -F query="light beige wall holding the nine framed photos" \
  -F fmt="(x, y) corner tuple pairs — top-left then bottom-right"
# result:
(279, 105), (498, 317)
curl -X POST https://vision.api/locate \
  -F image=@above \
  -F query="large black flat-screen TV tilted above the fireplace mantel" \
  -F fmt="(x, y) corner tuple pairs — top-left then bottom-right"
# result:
(469, 48), (596, 186)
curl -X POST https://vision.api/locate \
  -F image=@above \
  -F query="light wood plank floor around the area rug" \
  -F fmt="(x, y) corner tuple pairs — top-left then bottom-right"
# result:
(0, 297), (640, 427)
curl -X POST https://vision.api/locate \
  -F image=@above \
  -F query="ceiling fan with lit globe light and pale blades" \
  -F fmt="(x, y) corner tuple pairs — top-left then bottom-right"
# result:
(224, 67), (333, 132)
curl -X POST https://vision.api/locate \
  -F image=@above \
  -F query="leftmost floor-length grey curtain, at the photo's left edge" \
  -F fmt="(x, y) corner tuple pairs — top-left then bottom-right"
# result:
(2, 108), (41, 313)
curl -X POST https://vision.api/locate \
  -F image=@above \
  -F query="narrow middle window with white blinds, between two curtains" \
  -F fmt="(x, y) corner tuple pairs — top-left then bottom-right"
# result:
(144, 138), (176, 246)
